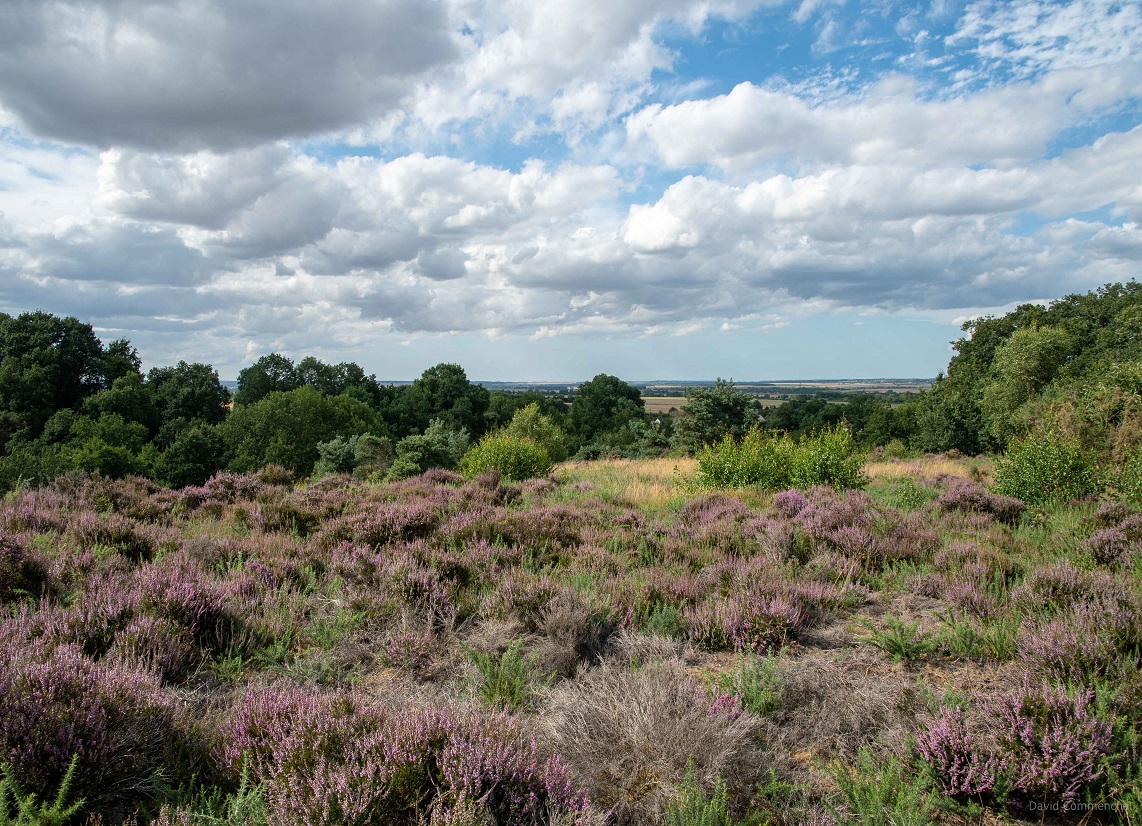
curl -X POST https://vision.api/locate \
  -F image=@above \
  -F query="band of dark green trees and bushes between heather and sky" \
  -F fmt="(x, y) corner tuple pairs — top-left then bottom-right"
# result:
(0, 281), (1142, 490)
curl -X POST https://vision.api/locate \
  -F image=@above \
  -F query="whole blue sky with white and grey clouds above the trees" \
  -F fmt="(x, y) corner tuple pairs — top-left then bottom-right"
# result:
(0, 0), (1142, 382)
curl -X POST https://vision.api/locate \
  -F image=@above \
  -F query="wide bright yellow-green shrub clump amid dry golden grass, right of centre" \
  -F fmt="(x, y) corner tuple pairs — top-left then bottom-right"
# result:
(698, 425), (866, 490)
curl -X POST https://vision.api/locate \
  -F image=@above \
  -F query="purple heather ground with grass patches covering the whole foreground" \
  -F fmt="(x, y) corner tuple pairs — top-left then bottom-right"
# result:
(0, 454), (1142, 826)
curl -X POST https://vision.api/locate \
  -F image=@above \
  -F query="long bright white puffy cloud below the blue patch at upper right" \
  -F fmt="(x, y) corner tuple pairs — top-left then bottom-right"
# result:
(626, 63), (1142, 169)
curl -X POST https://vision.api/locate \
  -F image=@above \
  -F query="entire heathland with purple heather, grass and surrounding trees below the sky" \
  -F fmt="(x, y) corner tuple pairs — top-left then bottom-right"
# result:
(0, 283), (1142, 826)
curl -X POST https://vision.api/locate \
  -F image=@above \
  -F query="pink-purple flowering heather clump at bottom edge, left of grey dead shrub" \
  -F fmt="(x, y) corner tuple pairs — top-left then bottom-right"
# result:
(223, 689), (588, 826)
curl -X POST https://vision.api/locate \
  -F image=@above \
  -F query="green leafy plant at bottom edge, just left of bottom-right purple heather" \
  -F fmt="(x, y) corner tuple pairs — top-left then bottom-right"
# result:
(828, 748), (934, 826)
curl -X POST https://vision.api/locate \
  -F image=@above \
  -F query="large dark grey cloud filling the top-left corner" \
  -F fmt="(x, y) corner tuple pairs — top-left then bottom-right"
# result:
(0, 0), (458, 151)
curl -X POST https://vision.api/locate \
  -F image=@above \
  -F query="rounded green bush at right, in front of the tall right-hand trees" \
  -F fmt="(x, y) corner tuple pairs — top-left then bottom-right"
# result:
(995, 427), (1102, 505)
